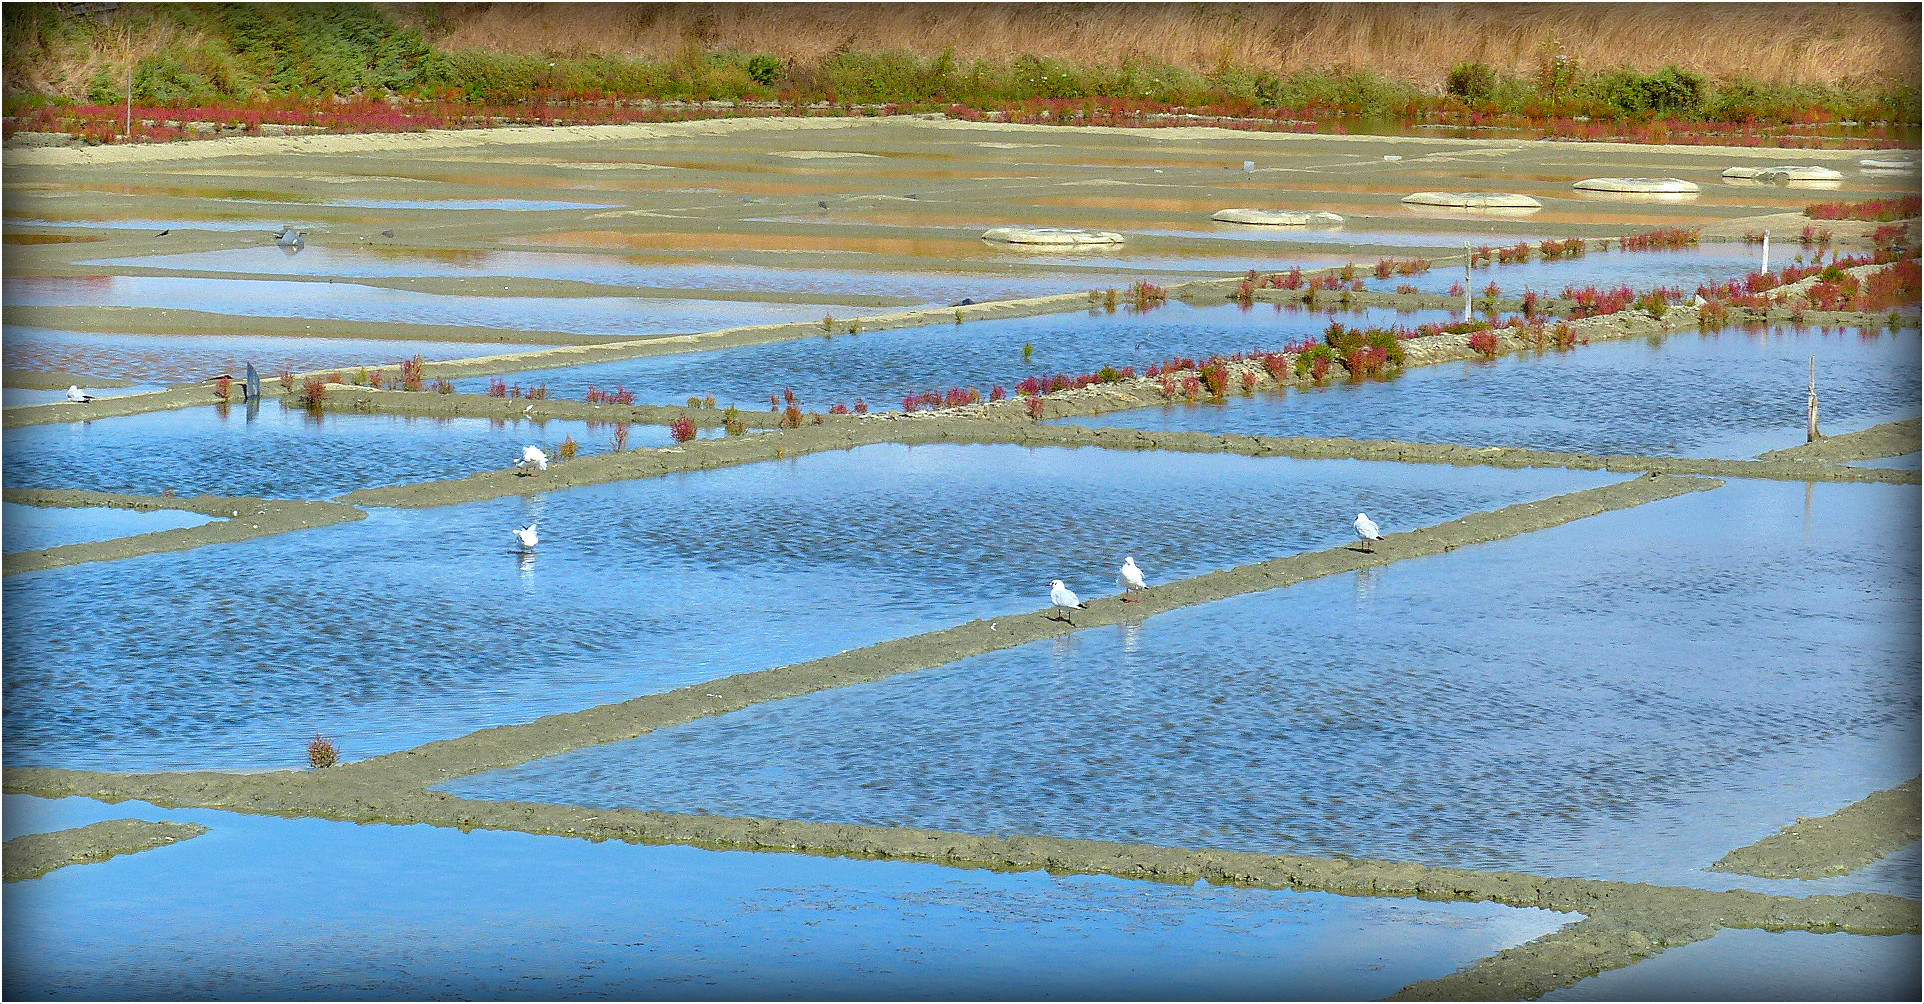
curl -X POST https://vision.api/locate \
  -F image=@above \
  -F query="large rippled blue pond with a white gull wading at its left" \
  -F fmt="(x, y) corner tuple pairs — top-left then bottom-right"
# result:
(0, 446), (1616, 769)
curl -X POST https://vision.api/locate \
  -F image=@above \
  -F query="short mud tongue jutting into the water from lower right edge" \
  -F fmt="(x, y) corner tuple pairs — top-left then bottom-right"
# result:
(1710, 777), (1920, 879)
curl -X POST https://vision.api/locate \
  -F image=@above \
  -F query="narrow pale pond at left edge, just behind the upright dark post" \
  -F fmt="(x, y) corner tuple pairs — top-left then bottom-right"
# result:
(4, 325), (552, 382)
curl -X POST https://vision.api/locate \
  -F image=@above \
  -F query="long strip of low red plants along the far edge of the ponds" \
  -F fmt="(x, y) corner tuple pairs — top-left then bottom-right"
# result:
(11, 92), (1905, 148)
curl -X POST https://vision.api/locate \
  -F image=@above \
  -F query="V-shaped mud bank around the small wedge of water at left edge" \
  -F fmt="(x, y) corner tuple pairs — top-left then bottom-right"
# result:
(0, 489), (367, 575)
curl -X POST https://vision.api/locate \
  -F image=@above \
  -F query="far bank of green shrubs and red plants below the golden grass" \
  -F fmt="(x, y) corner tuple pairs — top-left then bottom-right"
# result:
(0, 4), (1920, 142)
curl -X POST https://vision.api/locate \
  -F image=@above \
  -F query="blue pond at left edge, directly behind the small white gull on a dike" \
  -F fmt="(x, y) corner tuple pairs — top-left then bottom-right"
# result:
(0, 400), (669, 498)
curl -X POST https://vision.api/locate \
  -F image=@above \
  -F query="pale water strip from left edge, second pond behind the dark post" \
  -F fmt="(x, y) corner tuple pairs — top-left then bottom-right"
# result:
(0, 275), (875, 339)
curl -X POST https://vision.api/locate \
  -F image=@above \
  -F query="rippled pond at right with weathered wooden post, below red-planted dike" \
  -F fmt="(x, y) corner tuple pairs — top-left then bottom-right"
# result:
(1068, 329), (1918, 458)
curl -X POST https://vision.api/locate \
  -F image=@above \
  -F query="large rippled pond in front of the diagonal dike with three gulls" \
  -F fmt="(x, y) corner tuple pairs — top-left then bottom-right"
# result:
(444, 481), (1918, 894)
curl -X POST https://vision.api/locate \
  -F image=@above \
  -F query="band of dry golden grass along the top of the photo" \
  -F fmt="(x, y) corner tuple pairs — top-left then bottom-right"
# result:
(389, 4), (1920, 87)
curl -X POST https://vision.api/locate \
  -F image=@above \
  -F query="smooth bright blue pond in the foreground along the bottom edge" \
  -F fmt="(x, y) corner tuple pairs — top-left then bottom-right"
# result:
(4, 794), (1574, 1000)
